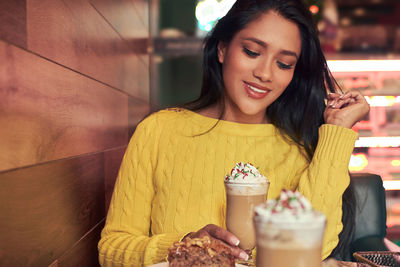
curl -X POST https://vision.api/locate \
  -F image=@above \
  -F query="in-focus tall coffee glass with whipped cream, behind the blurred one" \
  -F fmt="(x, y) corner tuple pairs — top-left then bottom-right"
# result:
(225, 162), (269, 262)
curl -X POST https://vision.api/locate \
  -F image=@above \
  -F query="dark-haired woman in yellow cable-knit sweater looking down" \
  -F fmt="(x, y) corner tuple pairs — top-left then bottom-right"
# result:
(99, 0), (369, 266)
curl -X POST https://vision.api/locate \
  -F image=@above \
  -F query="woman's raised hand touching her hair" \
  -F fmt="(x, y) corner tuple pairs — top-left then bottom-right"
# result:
(324, 90), (369, 128)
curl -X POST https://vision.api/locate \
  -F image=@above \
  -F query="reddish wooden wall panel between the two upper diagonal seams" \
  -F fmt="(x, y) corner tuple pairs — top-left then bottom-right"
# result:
(27, 0), (149, 100)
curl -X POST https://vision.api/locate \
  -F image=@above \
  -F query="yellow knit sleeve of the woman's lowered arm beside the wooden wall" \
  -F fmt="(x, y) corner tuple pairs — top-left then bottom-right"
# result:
(98, 116), (185, 267)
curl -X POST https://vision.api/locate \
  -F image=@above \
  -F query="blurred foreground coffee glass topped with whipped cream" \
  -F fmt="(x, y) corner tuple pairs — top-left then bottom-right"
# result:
(254, 190), (326, 267)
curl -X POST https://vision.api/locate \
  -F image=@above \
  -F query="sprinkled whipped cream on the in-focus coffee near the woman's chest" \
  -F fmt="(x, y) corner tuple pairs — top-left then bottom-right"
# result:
(225, 162), (268, 184)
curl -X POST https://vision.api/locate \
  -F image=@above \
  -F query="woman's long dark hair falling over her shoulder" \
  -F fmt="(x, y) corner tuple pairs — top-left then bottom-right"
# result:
(184, 0), (353, 260)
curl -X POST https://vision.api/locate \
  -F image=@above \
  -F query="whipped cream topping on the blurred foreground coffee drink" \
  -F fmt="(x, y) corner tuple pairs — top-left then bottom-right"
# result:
(254, 189), (325, 224)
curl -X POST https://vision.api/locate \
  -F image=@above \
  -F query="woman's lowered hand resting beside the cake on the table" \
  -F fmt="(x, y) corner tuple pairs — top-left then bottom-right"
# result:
(183, 224), (249, 260)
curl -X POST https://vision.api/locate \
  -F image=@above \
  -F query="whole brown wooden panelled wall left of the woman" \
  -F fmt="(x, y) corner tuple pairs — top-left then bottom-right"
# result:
(0, 0), (151, 267)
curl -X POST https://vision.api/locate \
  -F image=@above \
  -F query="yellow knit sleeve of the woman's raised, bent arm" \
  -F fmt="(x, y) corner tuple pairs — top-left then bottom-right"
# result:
(298, 124), (358, 259)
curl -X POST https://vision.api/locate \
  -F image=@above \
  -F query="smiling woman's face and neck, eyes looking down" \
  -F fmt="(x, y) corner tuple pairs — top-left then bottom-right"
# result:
(218, 11), (301, 123)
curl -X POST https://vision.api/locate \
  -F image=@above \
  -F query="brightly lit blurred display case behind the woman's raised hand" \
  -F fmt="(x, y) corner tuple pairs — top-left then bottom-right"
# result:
(328, 55), (400, 239)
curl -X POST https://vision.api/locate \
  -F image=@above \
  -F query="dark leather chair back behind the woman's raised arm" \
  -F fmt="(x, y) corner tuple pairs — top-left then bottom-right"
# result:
(332, 173), (388, 261)
